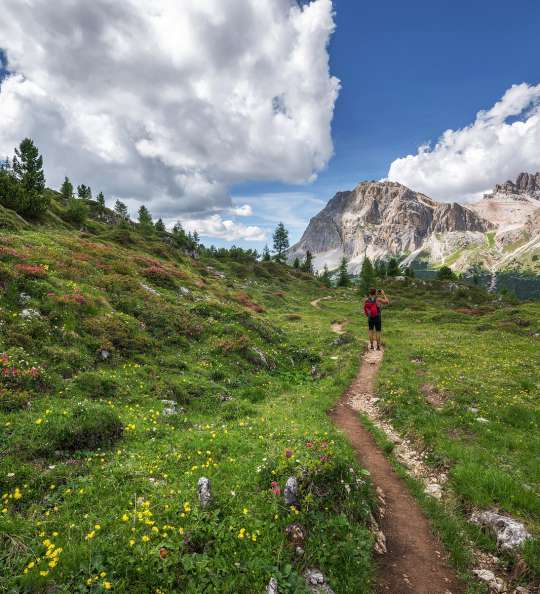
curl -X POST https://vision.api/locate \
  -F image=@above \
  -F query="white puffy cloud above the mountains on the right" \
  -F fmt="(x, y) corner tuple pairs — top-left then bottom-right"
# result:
(388, 83), (540, 202)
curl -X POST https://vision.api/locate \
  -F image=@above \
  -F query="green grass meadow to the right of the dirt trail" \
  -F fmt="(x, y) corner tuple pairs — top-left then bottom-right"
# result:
(378, 285), (540, 576)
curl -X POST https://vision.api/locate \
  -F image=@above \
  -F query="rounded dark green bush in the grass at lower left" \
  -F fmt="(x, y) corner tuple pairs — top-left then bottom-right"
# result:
(38, 402), (124, 452)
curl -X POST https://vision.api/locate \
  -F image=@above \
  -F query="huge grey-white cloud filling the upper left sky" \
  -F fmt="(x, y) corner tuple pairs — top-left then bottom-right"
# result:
(0, 0), (339, 218)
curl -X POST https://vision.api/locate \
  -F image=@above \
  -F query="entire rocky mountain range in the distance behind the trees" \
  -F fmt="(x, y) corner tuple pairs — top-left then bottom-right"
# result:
(288, 173), (540, 274)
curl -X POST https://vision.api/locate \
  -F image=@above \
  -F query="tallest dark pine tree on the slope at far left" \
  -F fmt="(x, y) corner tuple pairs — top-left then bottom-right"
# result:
(13, 138), (50, 217)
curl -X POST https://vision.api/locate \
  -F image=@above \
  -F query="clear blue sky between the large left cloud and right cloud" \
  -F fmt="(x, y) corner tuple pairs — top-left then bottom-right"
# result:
(230, 0), (540, 245)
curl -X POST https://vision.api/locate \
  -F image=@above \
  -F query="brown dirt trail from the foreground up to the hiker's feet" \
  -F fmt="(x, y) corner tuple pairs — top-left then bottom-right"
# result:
(330, 351), (463, 594)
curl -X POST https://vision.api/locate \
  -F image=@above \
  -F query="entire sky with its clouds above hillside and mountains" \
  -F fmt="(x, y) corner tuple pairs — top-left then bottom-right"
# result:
(0, 0), (540, 249)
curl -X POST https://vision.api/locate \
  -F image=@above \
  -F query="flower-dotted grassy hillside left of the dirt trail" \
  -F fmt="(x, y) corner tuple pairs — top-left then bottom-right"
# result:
(0, 208), (372, 593)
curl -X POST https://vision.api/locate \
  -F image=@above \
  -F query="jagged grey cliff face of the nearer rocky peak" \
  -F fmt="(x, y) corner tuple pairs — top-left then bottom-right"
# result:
(289, 182), (493, 272)
